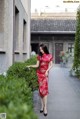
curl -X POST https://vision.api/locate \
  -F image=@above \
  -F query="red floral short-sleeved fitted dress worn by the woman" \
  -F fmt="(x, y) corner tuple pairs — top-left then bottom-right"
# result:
(37, 54), (53, 97)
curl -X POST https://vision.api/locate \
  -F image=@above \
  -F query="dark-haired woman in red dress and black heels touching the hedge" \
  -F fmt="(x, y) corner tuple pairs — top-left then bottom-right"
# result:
(28, 44), (53, 116)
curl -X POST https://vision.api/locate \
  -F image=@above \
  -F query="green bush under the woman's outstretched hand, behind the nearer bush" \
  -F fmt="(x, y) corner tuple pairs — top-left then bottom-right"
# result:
(7, 57), (38, 91)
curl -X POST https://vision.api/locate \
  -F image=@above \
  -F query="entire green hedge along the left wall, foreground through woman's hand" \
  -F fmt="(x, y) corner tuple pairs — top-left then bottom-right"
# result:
(0, 57), (38, 119)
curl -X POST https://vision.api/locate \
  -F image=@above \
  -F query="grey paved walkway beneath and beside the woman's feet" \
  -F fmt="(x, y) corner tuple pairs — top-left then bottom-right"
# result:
(34, 66), (80, 119)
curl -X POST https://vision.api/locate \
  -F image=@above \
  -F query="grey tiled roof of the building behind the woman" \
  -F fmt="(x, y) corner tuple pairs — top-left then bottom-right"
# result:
(31, 19), (76, 32)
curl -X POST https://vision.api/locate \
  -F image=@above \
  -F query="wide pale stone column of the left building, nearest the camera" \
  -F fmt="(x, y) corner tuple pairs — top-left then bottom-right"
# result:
(3, 0), (14, 71)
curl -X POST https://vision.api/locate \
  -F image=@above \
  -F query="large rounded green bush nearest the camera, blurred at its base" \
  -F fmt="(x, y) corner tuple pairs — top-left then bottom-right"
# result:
(0, 76), (37, 119)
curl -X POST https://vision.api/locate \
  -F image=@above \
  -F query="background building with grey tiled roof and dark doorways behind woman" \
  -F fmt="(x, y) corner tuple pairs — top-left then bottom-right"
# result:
(31, 13), (76, 64)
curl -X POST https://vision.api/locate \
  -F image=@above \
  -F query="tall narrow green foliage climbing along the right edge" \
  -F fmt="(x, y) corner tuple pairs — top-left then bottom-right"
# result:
(73, 6), (80, 77)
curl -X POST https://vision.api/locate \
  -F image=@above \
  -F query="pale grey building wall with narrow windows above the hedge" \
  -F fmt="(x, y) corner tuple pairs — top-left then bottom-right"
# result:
(0, 0), (31, 73)
